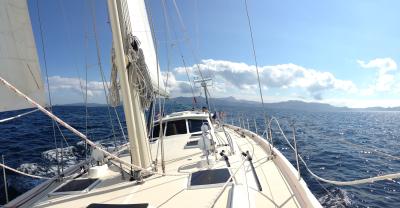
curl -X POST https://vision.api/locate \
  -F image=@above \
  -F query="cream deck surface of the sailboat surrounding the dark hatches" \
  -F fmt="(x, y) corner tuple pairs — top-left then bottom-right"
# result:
(14, 128), (300, 207)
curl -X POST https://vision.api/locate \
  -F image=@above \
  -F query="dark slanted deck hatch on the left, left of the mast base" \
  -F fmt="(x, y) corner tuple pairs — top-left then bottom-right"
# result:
(50, 178), (100, 195)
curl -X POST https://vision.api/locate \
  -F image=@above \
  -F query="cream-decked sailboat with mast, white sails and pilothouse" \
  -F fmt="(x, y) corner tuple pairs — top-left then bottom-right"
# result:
(0, 0), (321, 208)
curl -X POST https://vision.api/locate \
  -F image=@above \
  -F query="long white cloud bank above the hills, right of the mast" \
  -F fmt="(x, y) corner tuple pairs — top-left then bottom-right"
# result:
(174, 59), (357, 99)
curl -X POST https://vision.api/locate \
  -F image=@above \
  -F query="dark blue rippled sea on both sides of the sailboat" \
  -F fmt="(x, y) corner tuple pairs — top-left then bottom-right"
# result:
(0, 105), (400, 207)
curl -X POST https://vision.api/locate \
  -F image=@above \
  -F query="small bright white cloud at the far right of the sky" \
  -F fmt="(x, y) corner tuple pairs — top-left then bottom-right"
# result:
(357, 58), (397, 92)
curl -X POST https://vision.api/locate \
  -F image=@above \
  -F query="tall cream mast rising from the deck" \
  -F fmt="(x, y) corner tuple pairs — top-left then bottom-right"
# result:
(107, 0), (150, 168)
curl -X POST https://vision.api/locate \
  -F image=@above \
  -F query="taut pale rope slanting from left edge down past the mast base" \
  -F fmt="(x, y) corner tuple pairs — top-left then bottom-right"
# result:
(0, 76), (187, 176)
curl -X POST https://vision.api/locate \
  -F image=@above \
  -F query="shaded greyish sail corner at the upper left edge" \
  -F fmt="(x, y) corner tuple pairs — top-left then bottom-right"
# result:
(0, 0), (45, 111)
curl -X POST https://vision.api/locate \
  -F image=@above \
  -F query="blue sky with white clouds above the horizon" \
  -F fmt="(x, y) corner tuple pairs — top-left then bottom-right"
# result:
(28, 0), (400, 107)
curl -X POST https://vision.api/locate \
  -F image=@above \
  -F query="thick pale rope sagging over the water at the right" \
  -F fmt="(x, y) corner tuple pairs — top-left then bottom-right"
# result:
(270, 117), (400, 186)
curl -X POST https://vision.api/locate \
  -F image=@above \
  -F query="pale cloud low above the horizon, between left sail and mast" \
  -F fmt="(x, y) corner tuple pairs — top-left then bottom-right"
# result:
(49, 76), (108, 97)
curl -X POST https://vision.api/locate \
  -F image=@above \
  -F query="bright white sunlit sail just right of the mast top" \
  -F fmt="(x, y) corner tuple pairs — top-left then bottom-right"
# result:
(121, 0), (167, 95)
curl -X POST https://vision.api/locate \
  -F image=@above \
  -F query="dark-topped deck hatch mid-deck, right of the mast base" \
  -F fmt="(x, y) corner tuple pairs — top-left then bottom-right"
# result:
(189, 168), (232, 189)
